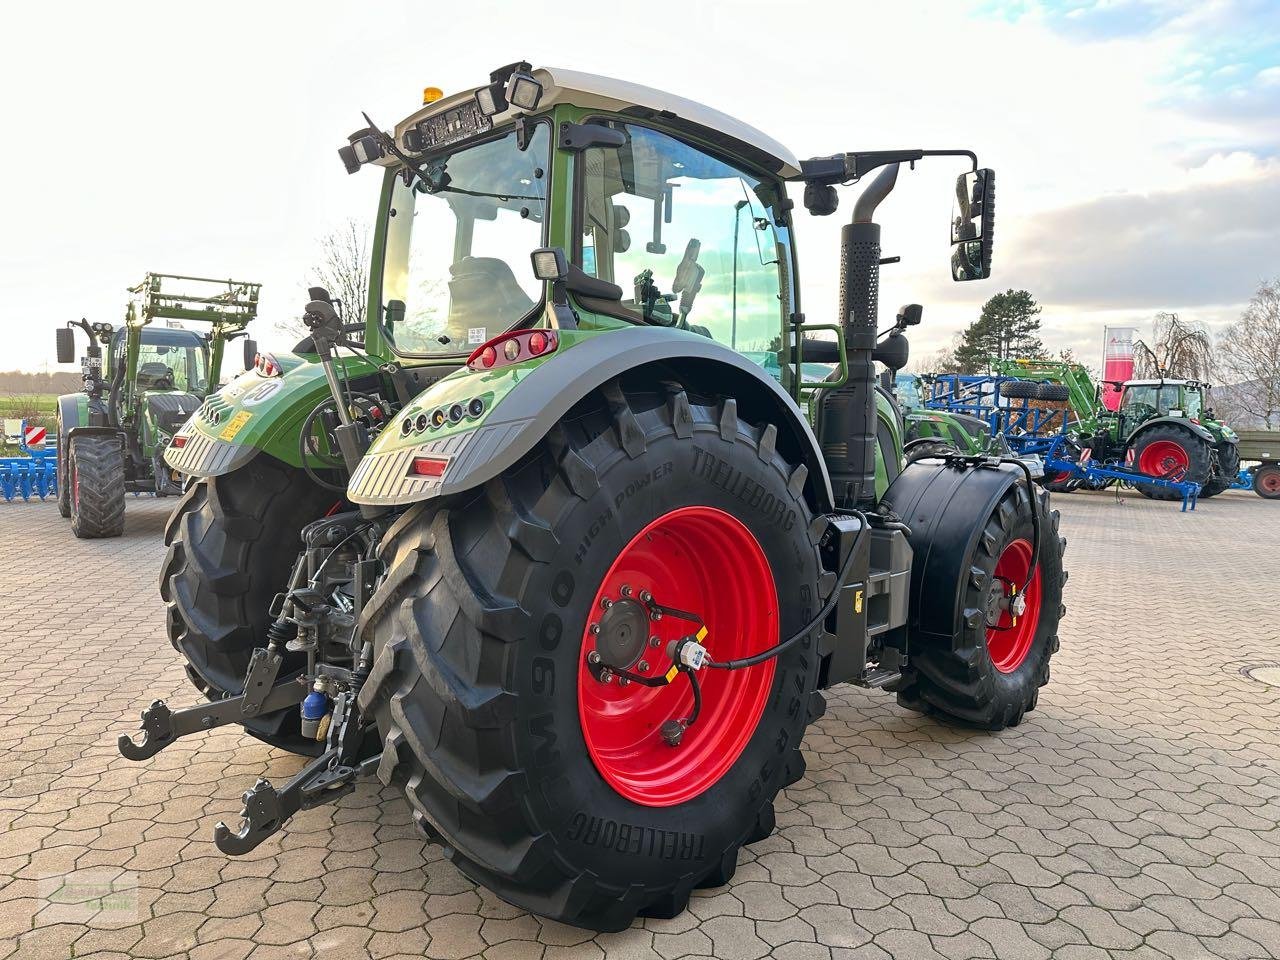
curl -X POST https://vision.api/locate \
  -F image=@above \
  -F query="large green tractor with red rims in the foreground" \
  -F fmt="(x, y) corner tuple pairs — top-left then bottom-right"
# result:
(119, 63), (1065, 929)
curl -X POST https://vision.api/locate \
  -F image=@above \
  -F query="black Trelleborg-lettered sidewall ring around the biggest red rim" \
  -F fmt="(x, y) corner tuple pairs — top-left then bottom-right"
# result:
(508, 431), (819, 883)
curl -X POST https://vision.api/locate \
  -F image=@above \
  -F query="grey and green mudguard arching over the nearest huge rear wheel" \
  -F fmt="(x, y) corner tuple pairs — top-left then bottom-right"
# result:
(347, 326), (832, 511)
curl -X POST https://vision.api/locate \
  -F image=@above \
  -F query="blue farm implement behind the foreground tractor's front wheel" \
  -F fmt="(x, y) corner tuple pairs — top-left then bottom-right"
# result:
(924, 374), (1201, 512)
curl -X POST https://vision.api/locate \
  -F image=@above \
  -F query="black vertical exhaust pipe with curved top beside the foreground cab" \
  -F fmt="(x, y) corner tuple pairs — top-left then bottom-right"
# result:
(819, 164), (899, 507)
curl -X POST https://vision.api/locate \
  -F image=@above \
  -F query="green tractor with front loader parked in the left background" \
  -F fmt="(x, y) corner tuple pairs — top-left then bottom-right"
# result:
(56, 274), (260, 539)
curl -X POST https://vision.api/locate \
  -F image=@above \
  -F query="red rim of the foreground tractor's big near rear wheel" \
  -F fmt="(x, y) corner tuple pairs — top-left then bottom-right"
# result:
(577, 507), (778, 806)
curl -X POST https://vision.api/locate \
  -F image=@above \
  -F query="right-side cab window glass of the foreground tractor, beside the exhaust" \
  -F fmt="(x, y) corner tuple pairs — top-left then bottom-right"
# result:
(577, 123), (791, 372)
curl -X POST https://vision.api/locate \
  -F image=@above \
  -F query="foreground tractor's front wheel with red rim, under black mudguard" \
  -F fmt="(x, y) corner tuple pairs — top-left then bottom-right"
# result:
(897, 483), (1066, 730)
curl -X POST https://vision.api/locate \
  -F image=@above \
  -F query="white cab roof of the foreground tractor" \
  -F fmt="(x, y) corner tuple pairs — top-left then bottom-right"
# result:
(394, 67), (800, 179)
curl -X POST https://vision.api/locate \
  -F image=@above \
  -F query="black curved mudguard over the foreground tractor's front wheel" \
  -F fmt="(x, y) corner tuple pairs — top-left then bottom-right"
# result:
(884, 460), (1018, 650)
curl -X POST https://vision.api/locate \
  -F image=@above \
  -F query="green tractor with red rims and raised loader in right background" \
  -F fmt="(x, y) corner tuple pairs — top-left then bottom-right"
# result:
(992, 360), (1240, 500)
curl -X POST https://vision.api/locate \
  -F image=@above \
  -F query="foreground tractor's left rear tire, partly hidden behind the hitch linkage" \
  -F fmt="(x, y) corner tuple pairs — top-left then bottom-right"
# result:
(160, 454), (337, 755)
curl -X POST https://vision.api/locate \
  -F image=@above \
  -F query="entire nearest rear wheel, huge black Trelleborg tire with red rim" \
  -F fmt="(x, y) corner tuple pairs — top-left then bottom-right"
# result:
(361, 381), (823, 931)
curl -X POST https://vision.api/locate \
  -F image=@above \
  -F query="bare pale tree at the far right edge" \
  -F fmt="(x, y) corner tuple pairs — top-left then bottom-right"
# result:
(1217, 278), (1280, 430)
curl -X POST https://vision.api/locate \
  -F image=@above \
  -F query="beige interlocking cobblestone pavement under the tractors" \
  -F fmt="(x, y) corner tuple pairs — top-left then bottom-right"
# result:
(0, 494), (1280, 960)
